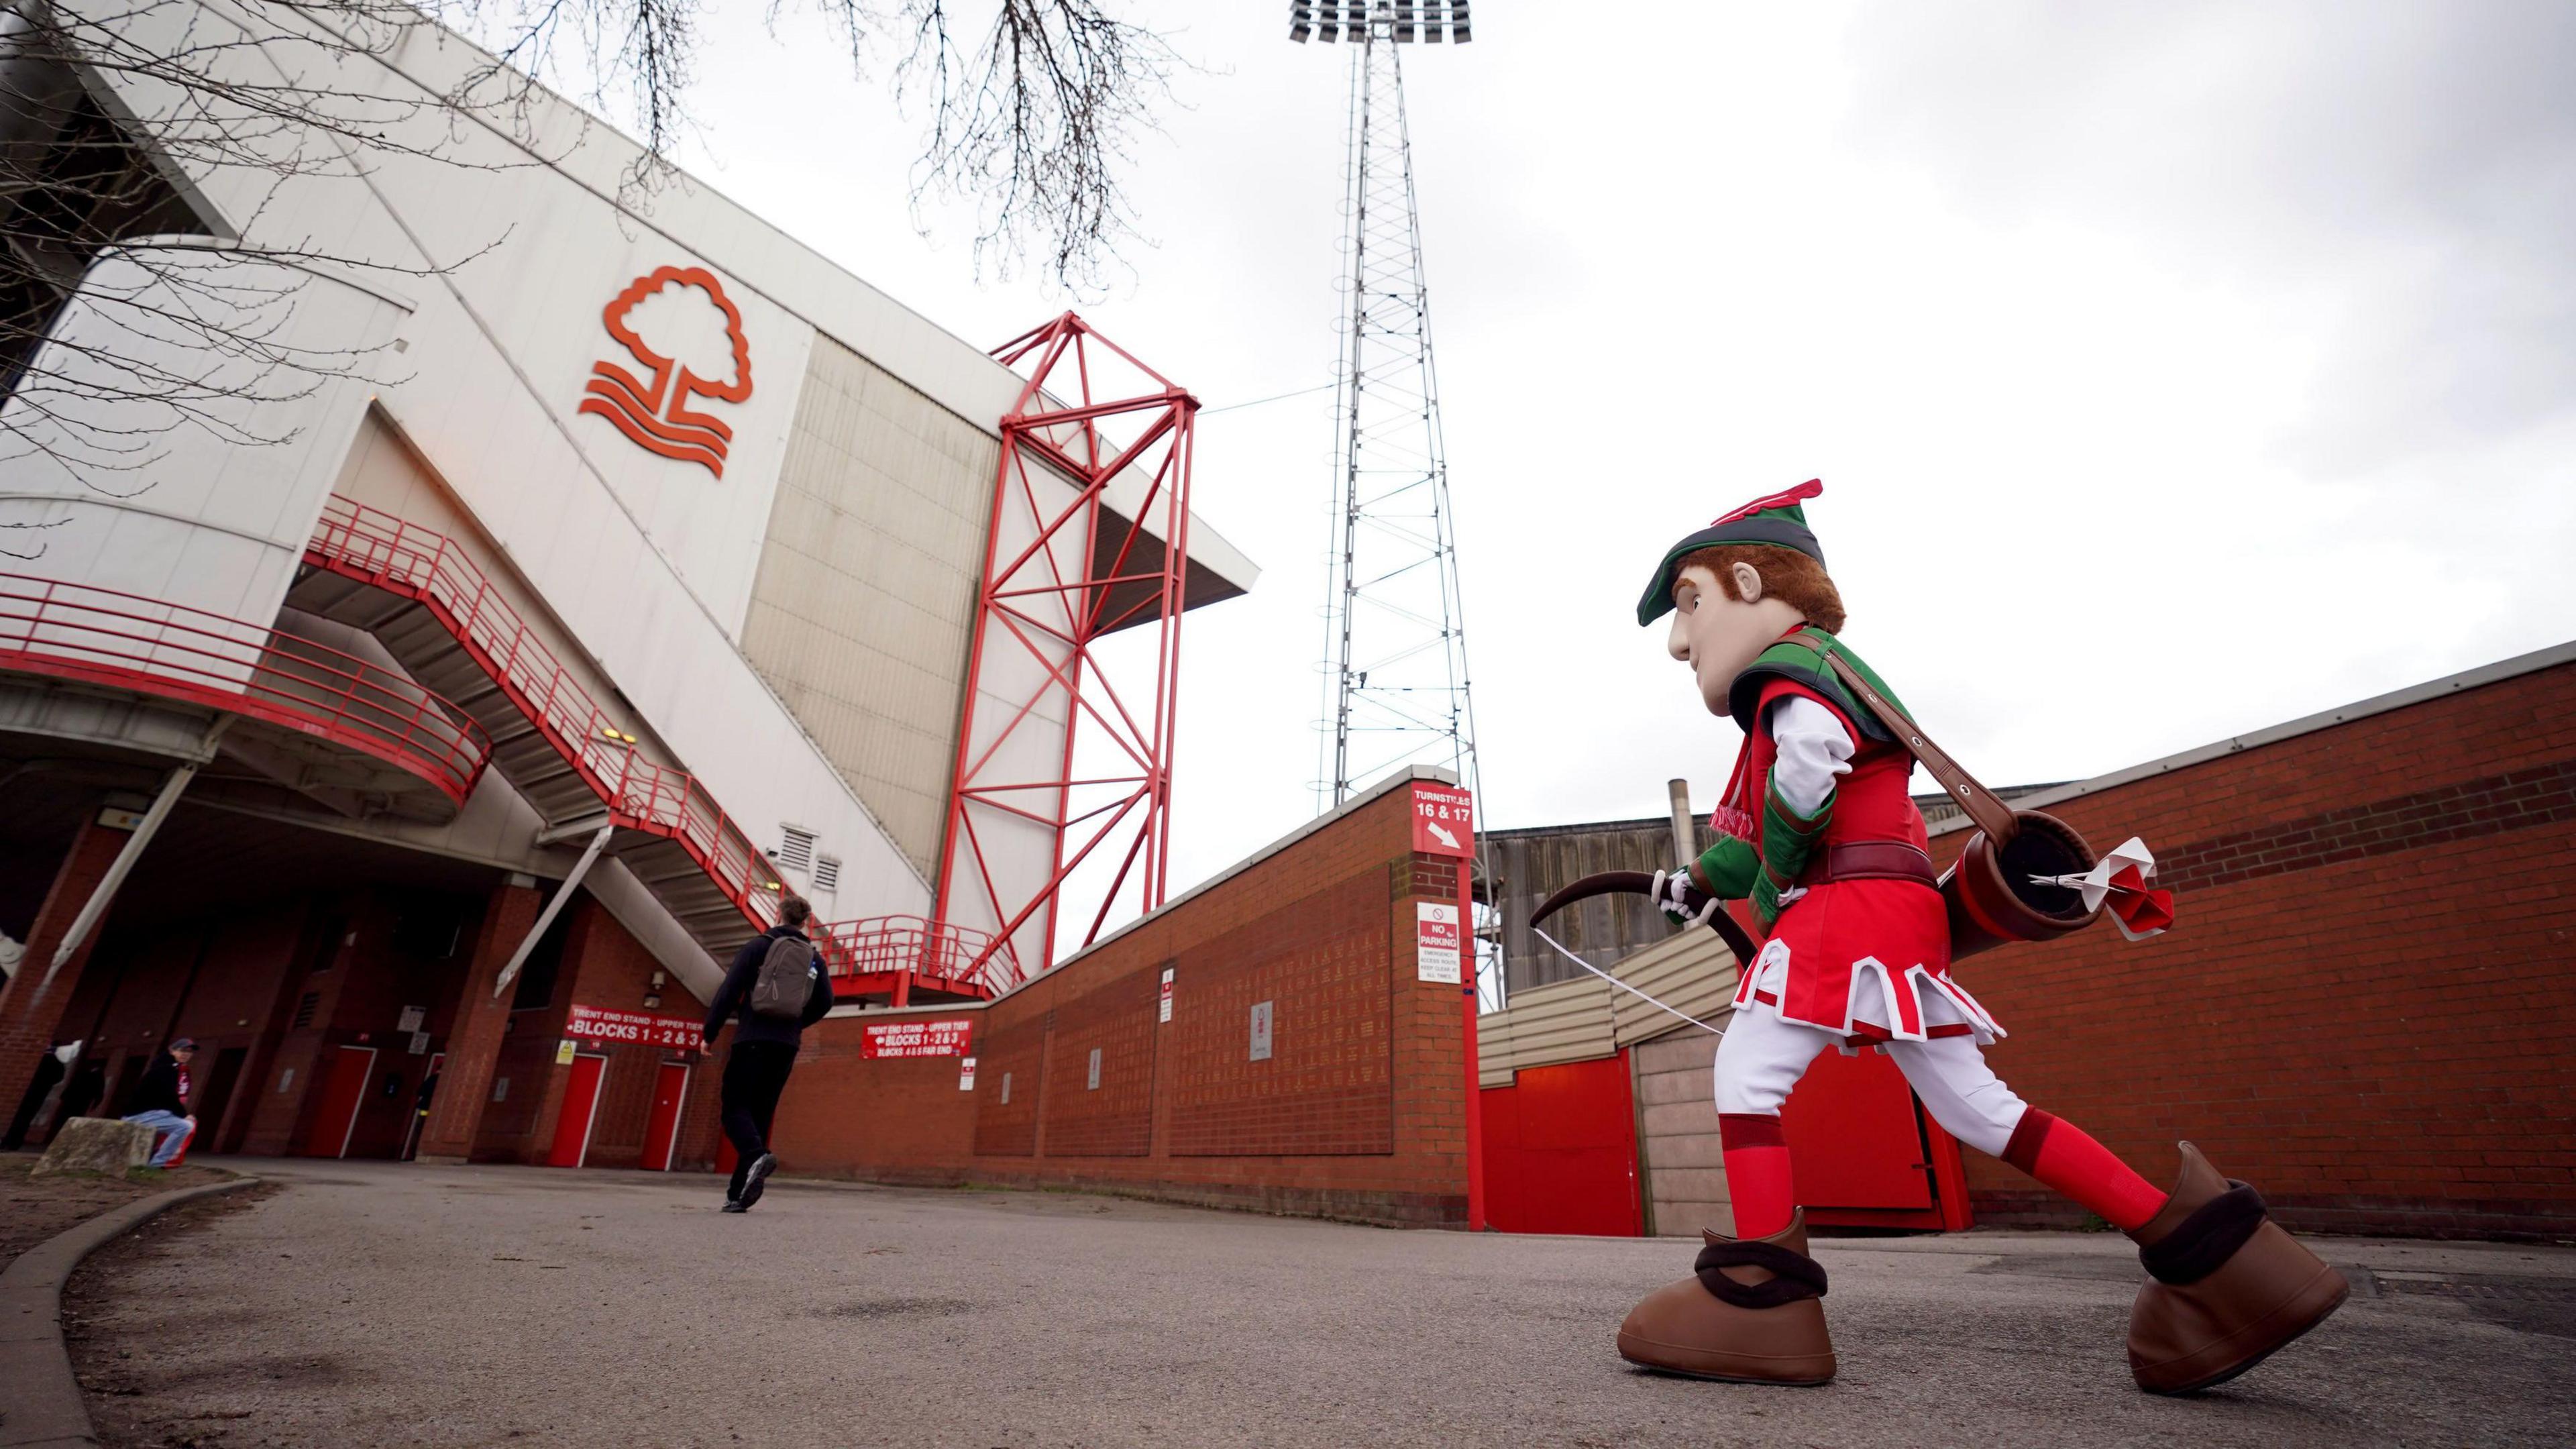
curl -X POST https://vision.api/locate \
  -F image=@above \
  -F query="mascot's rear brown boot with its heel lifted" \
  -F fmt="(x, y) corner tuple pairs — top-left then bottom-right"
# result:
(2128, 1142), (2352, 1395)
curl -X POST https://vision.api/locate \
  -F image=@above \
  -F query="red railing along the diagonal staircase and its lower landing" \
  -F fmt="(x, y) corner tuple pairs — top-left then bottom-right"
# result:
(304, 495), (994, 996)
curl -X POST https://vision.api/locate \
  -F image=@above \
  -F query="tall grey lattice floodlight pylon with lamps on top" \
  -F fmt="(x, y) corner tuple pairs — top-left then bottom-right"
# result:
(1288, 0), (1479, 807)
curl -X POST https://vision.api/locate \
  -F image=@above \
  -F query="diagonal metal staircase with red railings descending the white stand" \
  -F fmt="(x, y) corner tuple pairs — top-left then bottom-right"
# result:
(286, 495), (991, 1000)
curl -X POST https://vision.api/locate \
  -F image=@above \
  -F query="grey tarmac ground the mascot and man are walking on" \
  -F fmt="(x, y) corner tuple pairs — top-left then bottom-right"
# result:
(55, 1161), (2576, 1449)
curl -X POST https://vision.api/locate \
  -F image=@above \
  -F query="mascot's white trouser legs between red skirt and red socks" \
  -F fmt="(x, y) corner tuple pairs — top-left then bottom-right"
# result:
(1718, 993), (2027, 1158)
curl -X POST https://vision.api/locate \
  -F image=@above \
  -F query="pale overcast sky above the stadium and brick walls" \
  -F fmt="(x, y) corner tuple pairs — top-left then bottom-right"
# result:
(623, 0), (2576, 887)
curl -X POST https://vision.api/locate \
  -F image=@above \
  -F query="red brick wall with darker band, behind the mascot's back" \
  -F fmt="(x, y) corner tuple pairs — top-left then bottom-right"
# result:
(1932, 665), (2576, 1238)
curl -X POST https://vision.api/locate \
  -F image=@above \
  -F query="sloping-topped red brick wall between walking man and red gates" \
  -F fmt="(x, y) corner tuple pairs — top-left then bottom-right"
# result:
(775, 789), (1468, 1227)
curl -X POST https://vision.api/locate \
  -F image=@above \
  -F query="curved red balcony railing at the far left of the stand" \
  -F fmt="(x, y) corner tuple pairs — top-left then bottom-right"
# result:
(0, 572), (492, 804)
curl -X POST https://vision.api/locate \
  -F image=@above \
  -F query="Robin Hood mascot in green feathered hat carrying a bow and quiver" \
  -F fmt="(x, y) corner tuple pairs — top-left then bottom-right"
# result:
(1561, 482), (2347, 1392)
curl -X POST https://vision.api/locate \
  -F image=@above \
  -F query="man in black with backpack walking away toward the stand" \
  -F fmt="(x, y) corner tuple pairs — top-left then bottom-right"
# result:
(703, 895), (832, 1212)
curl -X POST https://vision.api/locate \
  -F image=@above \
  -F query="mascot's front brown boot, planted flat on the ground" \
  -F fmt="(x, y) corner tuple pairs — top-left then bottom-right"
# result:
(1618, 1212), (1834, 1385)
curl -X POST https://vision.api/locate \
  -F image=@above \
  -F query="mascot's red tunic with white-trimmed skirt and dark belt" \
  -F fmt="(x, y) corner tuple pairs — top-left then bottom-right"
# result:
(1726, 678), (2004, 1042)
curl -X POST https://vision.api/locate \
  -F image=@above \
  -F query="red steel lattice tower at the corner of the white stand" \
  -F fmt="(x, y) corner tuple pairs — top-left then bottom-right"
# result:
(938, 312), (1198, 985)
